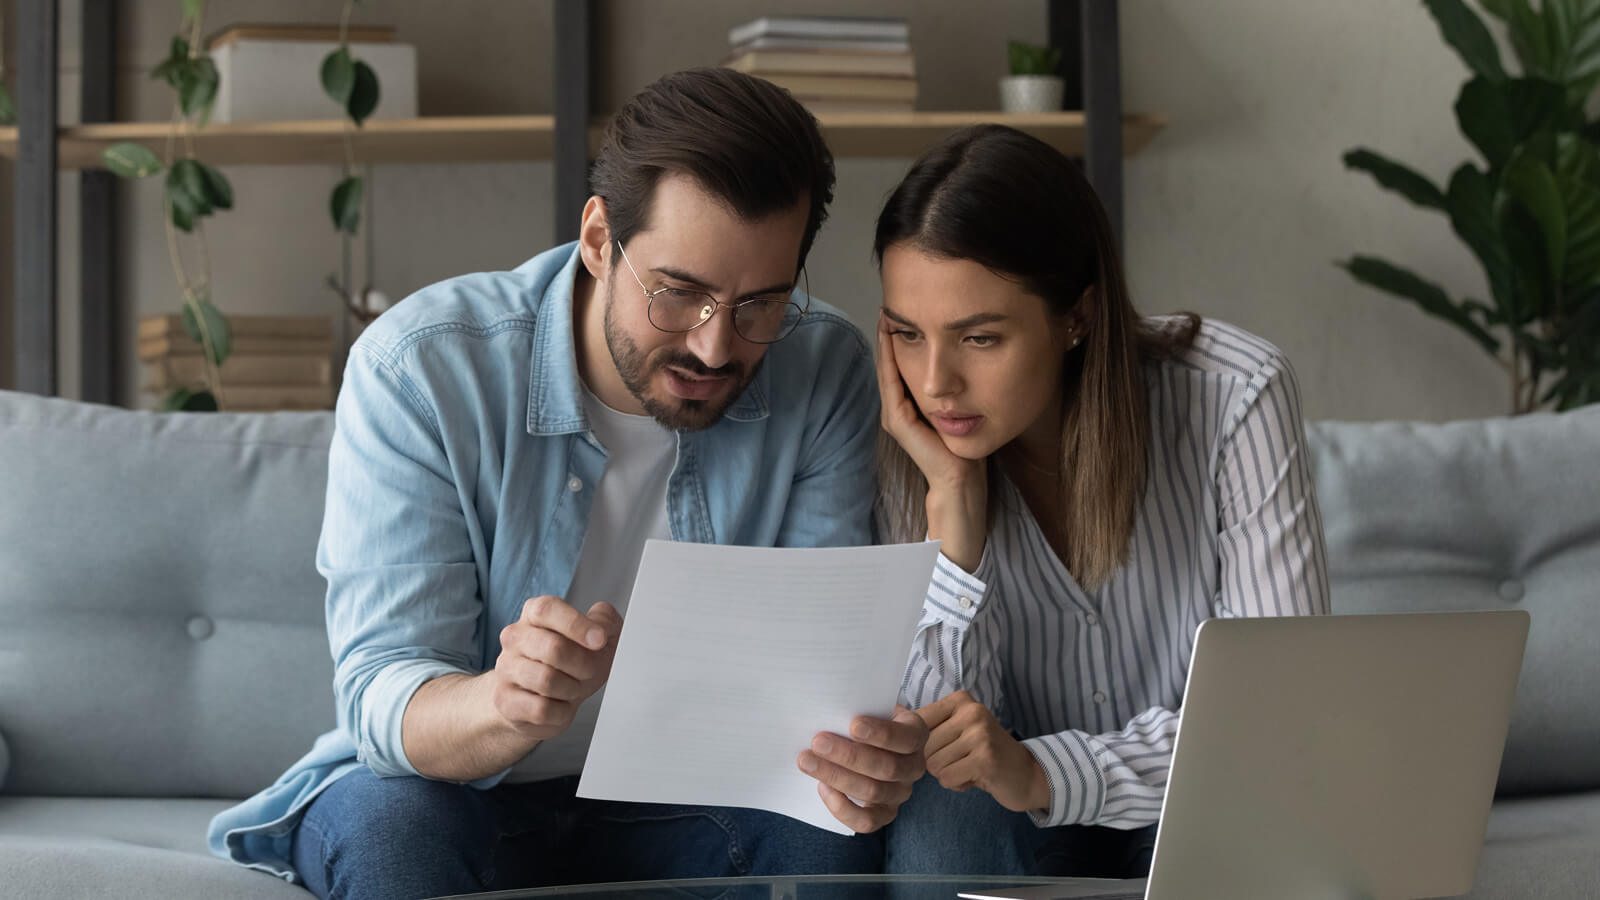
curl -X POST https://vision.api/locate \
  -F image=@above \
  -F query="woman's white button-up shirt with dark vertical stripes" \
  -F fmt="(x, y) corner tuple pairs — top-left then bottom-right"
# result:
(901, 320), (1328, 828)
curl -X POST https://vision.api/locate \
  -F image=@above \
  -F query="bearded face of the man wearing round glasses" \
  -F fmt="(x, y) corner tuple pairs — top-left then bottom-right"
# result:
(603, 175), (808, 431)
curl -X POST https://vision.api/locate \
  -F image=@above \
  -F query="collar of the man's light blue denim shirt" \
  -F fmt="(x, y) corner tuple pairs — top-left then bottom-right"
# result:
(528, 242), (768, 434)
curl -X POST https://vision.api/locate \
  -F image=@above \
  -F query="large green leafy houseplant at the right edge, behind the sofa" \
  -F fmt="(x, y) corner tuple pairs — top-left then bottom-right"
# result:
(1341, 0), (1600, 413)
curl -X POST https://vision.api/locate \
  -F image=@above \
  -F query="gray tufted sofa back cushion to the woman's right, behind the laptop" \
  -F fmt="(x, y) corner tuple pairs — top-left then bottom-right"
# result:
(1307, 407), (1600, 794)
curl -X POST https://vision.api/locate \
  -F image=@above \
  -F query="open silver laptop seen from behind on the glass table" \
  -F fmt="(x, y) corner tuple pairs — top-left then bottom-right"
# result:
(962, 610), (1528, 900)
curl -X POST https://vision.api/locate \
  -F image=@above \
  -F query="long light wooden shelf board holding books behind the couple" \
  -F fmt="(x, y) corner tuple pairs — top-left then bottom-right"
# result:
(0, 112), (1165, 170)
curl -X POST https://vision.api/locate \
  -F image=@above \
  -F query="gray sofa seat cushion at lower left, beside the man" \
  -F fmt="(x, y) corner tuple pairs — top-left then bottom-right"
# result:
(0, 796), (310, 900)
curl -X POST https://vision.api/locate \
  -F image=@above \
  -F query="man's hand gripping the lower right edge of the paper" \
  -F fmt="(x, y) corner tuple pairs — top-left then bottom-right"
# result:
(798, 706), (928, 833)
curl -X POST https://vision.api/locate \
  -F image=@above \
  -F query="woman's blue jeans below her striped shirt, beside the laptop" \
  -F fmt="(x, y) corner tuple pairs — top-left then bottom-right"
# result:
(883, 775), (1155, 878)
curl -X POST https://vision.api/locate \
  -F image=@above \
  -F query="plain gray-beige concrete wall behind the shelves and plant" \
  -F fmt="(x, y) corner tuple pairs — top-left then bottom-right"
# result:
(0, 0), (1509, 420)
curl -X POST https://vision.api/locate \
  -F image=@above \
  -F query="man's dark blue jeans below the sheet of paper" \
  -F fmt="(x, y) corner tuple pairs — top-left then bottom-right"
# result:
(291, 769), (883, 900)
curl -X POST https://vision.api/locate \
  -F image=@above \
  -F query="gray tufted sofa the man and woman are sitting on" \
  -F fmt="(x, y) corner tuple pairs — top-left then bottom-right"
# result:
(0, 392), (1600, 900)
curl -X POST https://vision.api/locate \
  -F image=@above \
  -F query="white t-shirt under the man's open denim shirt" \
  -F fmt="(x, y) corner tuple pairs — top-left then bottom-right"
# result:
(506, 377), (678, 781)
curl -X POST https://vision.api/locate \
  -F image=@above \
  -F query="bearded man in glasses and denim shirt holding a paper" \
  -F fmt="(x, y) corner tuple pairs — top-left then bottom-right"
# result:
(210, 69), (926, 900)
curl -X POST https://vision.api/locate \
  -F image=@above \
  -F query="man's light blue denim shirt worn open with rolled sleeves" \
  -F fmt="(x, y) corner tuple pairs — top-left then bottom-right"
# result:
(206, 245), (878, 879)
